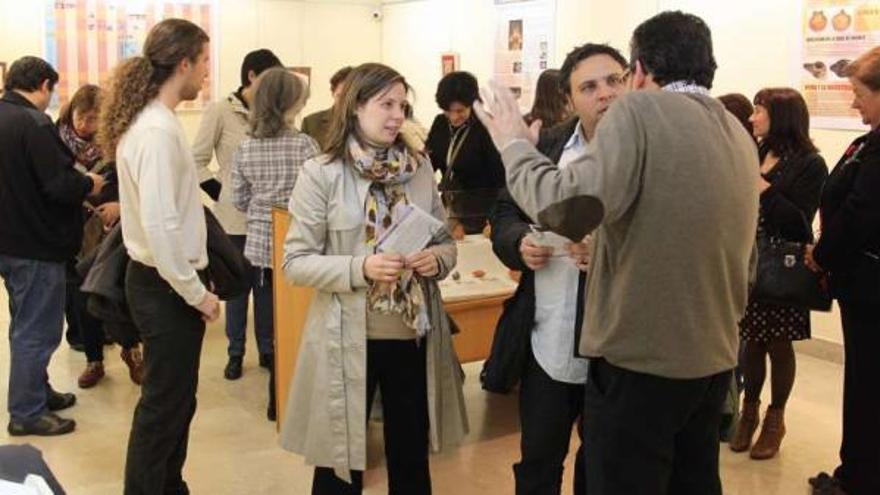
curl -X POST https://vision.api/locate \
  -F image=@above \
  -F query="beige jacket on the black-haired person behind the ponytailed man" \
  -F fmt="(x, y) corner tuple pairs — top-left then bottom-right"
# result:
(193, 93), (248, 235)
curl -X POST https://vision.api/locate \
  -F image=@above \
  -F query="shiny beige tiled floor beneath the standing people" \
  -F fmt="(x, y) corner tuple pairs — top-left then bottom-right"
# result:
(0, 290), (842, 495)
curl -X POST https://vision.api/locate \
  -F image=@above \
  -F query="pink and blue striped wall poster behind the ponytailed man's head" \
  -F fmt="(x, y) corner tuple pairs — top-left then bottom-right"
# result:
(44, 0), (218, 110)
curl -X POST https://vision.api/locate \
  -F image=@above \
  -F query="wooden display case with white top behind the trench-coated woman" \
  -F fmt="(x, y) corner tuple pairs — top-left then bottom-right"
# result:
(272, 208), (516, 425)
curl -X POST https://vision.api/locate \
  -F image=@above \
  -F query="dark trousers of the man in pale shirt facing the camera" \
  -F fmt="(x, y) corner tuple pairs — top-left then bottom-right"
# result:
(513, 354), (586, 495)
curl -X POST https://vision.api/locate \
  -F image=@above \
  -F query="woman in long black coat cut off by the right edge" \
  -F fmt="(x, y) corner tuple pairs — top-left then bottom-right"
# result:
(806, 48), (880, 495)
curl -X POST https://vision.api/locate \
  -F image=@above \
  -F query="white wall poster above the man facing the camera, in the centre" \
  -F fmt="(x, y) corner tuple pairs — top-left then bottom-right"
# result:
(493, 0), (556, 113)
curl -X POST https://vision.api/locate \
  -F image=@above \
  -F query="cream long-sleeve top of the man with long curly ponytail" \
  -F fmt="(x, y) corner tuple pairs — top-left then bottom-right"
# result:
(116, 100), (208, 306)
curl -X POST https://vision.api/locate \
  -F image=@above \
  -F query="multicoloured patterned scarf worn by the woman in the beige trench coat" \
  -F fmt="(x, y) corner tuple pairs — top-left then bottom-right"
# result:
(348, 139), (430, 337)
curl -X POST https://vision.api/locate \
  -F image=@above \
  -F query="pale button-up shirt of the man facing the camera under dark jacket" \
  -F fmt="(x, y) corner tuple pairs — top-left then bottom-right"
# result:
(532, 124), (587, 383)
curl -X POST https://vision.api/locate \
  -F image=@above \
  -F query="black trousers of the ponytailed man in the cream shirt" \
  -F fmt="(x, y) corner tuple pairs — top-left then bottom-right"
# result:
(125, 261), (205, 495)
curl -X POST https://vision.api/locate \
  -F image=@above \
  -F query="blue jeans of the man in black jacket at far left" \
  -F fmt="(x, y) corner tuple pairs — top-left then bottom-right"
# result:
(0, 254), (65, 423)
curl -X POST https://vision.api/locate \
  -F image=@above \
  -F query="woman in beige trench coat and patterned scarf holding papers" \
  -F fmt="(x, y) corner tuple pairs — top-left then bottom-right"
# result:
(281, 64), (468, 495)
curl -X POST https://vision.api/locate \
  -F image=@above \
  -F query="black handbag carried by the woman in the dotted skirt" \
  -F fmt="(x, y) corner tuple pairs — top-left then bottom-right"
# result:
(751, 235), (831, 311)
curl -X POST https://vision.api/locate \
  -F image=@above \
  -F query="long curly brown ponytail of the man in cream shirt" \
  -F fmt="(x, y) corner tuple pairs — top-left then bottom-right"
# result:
(97, 19), (209, 160)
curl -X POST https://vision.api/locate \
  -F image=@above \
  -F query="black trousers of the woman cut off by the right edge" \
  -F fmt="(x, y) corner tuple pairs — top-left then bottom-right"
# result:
(834, 301), (880, 495)
